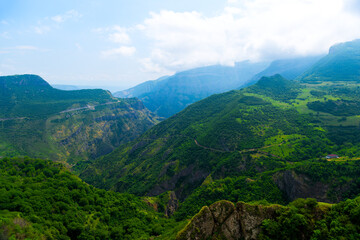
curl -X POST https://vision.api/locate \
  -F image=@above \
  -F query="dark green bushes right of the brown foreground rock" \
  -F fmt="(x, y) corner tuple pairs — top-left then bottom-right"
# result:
(259, 198), (360, 240)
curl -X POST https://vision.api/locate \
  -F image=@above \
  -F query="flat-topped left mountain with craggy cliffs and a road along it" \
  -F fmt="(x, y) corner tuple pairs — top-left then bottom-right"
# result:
(0, 75), (157, 164)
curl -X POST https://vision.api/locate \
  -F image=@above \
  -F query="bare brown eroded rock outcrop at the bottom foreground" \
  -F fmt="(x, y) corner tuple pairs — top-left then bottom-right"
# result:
(176, 201), (280, 240)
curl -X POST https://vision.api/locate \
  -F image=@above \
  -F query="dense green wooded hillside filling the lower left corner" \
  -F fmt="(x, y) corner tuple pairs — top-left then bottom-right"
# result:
(0, 158), (177, 240)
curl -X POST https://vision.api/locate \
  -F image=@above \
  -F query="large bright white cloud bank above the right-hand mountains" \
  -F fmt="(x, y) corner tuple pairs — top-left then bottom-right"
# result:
(136, 0), (360, 71)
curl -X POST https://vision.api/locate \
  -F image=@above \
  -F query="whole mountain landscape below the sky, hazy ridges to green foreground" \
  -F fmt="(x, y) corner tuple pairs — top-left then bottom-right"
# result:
(0, 40), (360, 240)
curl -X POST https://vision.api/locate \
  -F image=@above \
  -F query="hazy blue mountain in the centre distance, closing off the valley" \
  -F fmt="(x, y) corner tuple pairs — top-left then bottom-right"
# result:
(114, 61), (266, 118)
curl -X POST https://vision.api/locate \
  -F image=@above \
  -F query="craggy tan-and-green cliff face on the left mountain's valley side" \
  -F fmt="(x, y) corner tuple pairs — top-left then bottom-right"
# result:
(45, 100), (156, 163)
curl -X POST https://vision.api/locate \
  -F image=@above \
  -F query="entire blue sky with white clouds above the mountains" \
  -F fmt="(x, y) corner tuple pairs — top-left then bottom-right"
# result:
(0, 0), (360, 91)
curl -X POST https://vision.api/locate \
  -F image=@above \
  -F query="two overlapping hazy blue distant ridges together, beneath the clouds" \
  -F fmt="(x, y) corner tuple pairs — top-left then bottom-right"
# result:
(114, 56), (321, 118)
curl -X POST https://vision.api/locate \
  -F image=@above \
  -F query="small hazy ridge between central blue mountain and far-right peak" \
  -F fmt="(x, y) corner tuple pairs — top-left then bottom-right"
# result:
(245, 55), (323, 86)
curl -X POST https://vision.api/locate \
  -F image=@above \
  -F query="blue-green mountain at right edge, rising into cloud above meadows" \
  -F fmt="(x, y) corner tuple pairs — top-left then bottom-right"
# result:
(299, 40), (360, 83)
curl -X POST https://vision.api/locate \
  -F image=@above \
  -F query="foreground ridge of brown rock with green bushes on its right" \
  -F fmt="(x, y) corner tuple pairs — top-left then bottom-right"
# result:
(176, 197), (360, 240)
